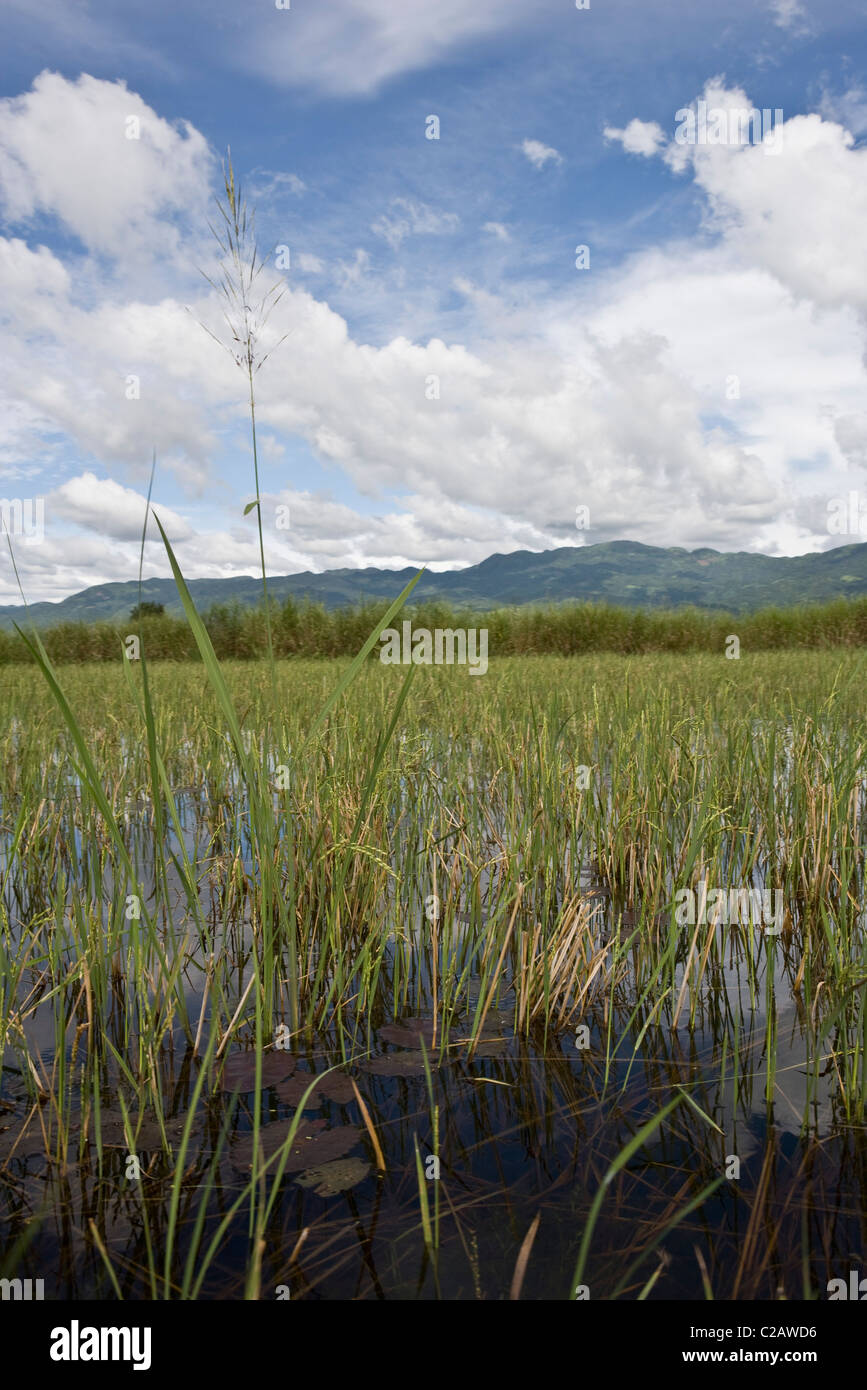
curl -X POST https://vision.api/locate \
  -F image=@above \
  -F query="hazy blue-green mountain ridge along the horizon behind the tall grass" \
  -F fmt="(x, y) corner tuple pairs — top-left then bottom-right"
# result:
(0, 541), (867, 630)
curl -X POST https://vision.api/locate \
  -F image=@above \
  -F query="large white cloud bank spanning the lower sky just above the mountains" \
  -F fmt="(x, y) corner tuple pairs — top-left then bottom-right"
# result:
(0, 73), (867, 600)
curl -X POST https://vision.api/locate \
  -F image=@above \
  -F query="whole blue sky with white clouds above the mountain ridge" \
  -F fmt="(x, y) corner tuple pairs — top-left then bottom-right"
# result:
(0, 0), (867, 603)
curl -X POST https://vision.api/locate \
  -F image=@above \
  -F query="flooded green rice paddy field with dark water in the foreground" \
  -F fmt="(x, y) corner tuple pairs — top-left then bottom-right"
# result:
(0, 632), (867, 1301)
